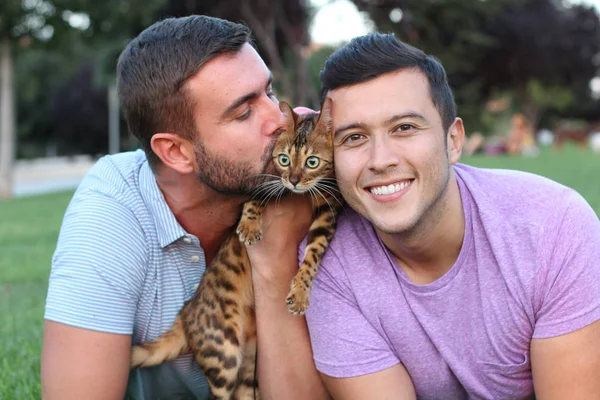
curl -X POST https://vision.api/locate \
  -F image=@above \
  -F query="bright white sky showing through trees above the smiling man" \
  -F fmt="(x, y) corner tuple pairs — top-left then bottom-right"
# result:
(310, 0), (600, 45)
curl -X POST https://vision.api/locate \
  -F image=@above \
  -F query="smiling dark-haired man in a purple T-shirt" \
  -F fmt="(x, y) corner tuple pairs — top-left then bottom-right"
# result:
(307, 33), (600, 400)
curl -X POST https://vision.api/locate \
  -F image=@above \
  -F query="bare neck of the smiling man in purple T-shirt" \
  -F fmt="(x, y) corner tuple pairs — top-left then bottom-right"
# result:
(378, 174), (465, 284)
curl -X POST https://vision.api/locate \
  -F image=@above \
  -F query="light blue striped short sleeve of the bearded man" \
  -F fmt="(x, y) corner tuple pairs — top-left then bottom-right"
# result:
(44, 189), (147, 334)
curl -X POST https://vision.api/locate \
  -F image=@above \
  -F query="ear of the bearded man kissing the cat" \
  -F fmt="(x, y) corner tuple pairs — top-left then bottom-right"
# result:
(150, 133), (197, 174)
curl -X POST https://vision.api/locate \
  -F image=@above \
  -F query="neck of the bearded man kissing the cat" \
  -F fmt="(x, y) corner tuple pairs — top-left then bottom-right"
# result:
(156, 168), (247, 264)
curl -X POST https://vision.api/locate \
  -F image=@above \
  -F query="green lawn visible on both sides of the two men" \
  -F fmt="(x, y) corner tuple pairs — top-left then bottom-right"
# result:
(0, 148), (600, 400)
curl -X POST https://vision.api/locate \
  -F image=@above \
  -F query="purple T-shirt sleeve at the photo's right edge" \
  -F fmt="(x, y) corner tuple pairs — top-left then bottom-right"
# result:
(533, 192), (600, 338)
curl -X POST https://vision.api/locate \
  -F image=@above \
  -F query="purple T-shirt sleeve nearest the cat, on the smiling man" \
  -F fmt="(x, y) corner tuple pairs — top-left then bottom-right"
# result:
(306, 248), (399, 378)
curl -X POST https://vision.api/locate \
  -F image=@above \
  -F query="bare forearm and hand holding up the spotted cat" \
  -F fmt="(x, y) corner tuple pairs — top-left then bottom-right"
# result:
(247, 195), (328, 400)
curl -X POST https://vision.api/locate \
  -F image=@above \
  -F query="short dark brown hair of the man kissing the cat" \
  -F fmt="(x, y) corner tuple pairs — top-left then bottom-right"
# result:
(117, 15), (252, 167)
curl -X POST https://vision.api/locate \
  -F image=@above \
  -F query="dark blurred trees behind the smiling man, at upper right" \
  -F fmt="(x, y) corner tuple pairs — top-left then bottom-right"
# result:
(353, 0), (600, 129)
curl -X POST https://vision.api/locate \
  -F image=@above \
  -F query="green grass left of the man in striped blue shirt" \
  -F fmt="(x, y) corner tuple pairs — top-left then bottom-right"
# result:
(0, 193), (72, 400)
